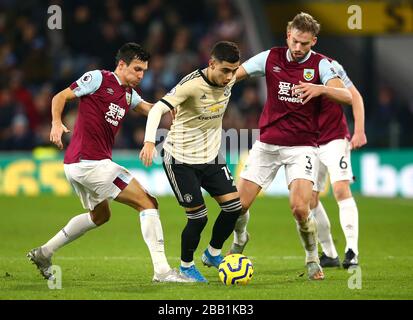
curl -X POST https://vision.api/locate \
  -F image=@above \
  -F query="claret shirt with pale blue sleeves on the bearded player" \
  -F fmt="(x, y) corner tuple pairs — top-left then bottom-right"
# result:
(242, 47), (338, 146)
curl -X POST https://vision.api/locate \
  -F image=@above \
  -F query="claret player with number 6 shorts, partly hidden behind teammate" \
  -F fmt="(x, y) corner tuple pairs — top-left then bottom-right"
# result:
(311, 60), (367, 269)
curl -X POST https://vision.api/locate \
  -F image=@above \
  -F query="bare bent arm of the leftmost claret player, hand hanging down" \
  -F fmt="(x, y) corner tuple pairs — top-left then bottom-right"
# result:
(50, 88), (76, 149)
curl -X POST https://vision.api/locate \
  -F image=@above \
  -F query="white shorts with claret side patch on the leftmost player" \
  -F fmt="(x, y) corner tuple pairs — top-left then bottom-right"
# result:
(64, 159), (133, 210)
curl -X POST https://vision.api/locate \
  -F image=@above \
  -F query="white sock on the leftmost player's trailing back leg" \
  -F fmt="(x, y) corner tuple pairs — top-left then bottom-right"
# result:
(41, 212), (97, 258)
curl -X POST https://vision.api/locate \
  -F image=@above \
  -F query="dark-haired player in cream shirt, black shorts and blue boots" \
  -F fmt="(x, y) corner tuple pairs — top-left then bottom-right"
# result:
(140, 41), (241, 282)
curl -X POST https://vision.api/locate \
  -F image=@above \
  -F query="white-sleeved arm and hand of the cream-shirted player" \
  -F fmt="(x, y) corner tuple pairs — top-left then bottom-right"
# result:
(139, 102), (170, 167)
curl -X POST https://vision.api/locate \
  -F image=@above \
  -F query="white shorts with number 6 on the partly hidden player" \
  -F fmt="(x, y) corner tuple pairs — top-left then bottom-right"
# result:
(313, 139), (353, 192)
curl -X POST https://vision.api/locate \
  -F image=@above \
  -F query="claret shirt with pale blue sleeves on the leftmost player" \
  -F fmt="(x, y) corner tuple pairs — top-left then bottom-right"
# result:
(64, 70), (142, 164)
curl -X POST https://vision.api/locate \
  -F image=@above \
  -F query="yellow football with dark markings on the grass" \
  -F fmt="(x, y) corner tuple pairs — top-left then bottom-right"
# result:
(218, 254), (254, 286)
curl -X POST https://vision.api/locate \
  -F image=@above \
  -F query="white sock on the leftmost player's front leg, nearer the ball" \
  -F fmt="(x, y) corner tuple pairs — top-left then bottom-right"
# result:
(139, 209), (171, 273)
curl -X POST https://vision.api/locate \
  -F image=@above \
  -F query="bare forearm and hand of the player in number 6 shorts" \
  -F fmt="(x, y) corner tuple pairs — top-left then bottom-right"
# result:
(349, 85), (367, 149)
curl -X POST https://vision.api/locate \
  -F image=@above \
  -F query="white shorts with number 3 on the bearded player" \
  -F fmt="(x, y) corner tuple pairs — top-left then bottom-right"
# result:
(240, 140), (318, 190)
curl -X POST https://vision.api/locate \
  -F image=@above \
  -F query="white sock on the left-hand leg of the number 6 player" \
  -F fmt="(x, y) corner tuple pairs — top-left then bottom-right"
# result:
(312, 201), (338, 258)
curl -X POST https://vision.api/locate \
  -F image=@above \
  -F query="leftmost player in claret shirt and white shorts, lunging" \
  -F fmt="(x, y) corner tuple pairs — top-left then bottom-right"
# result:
(28, 43), (191, 282)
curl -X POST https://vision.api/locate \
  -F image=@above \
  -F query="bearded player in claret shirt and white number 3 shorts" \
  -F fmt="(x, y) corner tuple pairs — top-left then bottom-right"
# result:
(230, 13), (352, 280)
